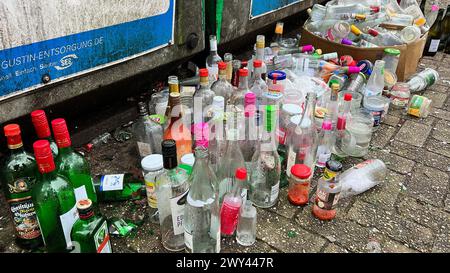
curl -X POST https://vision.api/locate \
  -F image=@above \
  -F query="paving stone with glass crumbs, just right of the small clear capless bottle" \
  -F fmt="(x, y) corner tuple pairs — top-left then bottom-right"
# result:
(257, 209), (326, 253)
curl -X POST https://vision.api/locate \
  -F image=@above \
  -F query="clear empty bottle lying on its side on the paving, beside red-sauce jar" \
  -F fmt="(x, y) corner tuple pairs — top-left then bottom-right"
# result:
(340, 159), (387, 198)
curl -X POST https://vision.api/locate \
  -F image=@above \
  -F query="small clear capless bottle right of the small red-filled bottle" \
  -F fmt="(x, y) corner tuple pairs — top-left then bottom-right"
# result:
(236, 200), (257, 246)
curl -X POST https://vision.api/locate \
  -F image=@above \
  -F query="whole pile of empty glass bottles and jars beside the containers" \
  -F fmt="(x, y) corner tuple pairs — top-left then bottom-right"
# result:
(2, 0), (439, 253)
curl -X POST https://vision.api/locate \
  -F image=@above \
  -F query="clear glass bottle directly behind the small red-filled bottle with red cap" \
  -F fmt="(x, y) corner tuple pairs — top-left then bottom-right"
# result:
(217, 129), (246, 204)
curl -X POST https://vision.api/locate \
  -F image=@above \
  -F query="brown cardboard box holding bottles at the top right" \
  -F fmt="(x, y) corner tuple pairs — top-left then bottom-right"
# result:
(300, 28), (428, 81)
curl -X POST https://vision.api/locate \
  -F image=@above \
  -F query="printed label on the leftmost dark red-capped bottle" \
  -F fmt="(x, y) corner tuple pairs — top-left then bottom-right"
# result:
(8, 196), (41, 240)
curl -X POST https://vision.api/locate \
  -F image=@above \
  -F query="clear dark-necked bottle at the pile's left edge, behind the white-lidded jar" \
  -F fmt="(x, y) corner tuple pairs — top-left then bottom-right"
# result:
(132, 102), (164, 157)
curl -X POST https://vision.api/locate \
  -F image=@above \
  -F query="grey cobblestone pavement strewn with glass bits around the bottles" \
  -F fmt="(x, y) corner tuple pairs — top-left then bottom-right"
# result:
(0, 53), (450, 253)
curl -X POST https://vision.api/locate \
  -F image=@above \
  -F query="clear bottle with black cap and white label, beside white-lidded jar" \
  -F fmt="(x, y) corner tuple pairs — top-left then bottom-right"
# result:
(156, 139), (189, 251)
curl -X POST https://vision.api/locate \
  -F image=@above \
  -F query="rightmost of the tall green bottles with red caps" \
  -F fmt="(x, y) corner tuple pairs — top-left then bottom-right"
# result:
(52, 118), (97, 206)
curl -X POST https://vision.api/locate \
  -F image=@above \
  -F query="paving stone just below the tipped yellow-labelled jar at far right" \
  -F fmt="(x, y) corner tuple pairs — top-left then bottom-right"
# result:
(395, 120), (431, 147)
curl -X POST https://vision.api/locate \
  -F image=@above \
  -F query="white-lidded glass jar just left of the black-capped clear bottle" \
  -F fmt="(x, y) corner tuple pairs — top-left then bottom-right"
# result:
(141, 154), (164, 224)
